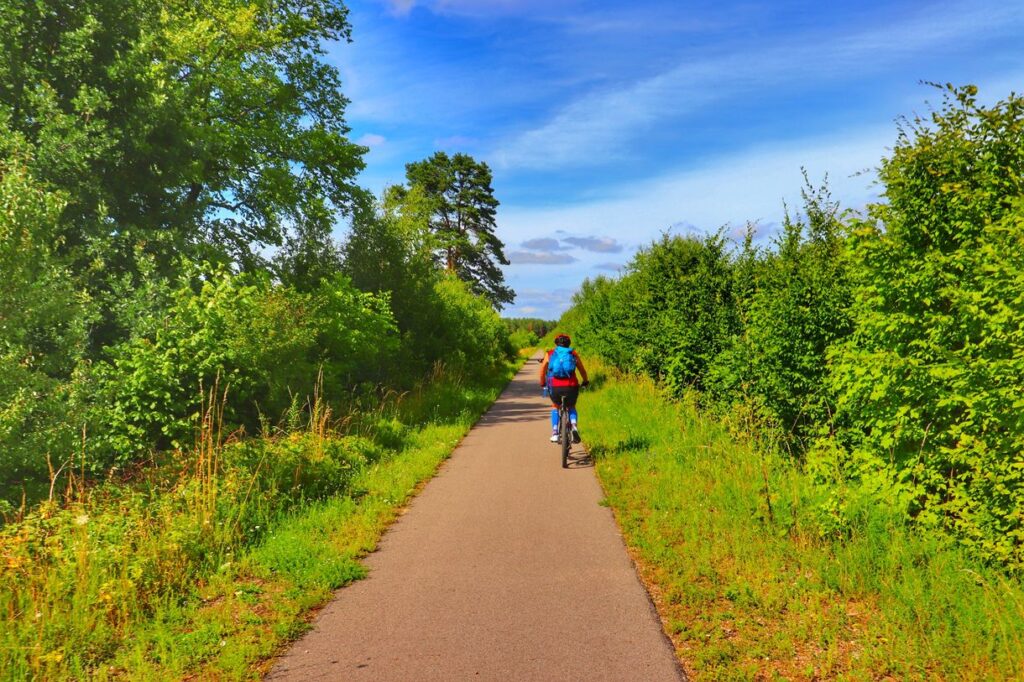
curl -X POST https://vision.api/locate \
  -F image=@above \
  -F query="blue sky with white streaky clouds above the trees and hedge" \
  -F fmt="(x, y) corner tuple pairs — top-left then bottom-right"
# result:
(329, 0), (1024, 317)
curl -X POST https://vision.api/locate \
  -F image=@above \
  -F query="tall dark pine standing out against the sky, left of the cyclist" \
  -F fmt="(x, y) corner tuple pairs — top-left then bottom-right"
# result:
(392, 152), (515, 309)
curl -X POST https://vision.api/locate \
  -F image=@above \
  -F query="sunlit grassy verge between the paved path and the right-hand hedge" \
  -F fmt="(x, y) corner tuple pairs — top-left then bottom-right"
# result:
(581, 360), (1024, 680)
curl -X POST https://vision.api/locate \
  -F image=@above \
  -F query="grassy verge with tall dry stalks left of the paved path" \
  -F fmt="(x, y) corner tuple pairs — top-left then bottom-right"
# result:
(0, 358), (513, 680)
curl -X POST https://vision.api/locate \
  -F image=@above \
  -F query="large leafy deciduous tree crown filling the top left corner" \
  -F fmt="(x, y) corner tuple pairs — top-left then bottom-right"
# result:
(0, 0), (365, 289)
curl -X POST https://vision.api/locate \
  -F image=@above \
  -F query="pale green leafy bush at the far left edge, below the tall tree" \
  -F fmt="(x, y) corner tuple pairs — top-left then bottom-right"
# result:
(0, 140), (92, 488)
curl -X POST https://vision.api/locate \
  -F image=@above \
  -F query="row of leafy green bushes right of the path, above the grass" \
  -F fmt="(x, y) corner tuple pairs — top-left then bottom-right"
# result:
(562, 86), (1024, 570)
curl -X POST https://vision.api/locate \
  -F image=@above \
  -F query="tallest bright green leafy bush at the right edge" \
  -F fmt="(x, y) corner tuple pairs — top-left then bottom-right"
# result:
(820, 87), (1024, 567)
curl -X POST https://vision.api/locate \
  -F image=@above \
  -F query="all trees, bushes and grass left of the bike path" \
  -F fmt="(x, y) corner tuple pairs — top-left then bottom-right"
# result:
(0, 0), (531, 680)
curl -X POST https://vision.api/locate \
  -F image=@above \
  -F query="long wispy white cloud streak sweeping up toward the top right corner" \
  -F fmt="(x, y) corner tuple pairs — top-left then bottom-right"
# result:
(494, 2), (1024, 169)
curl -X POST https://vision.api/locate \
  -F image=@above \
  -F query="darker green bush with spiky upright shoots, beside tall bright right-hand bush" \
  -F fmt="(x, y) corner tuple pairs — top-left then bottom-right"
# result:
(710, 178), (851, 452)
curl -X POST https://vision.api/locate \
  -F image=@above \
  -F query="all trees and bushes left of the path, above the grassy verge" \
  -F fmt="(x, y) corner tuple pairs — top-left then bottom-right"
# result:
(0, 0), (524, 501)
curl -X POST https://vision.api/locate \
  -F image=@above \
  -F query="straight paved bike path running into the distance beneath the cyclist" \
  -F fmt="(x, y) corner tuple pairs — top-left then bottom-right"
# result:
(268, 352), (683, 681)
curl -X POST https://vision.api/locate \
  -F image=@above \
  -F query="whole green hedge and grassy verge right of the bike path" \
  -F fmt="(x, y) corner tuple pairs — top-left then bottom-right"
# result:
(560, 86), (1024, 679)
